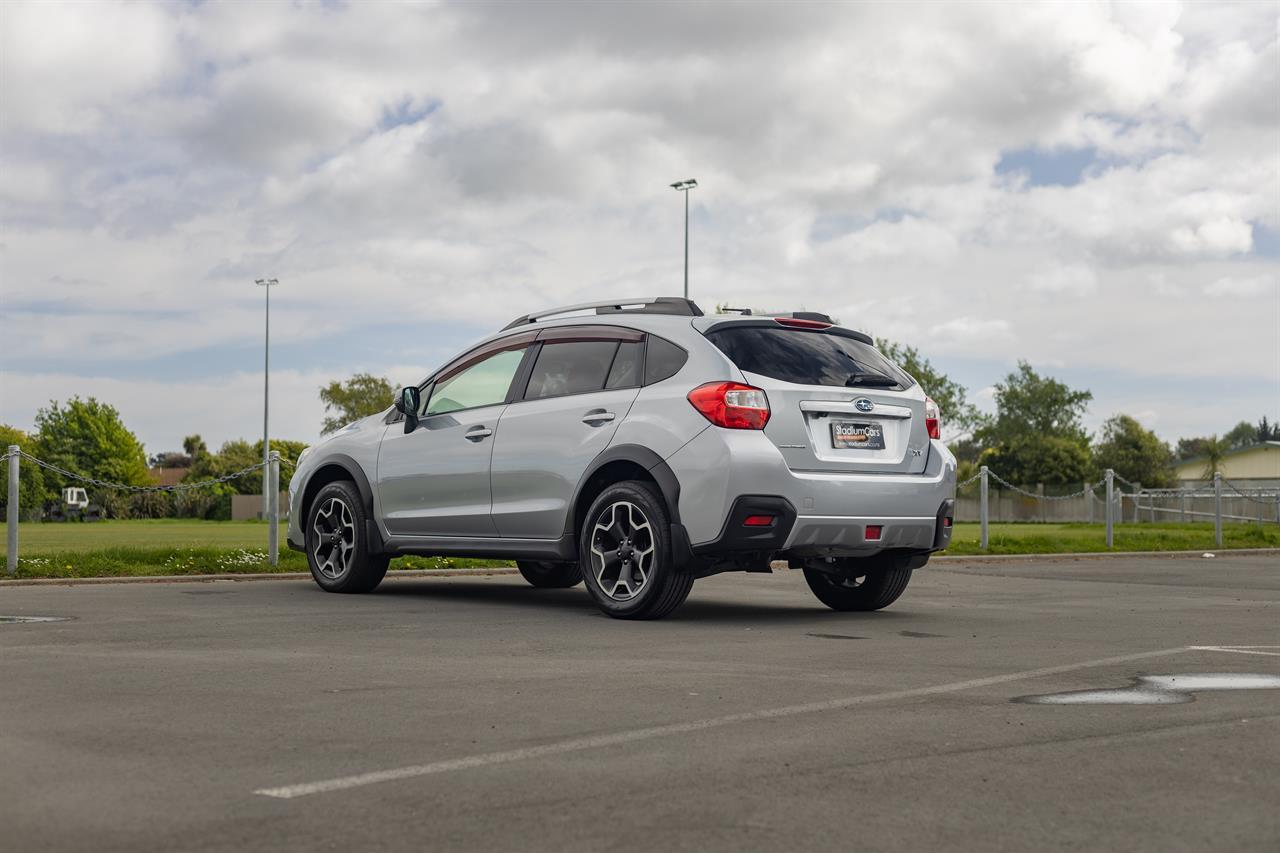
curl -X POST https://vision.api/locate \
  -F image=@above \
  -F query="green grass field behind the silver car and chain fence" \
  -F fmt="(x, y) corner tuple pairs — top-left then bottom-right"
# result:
(0, 519), (1280, 578)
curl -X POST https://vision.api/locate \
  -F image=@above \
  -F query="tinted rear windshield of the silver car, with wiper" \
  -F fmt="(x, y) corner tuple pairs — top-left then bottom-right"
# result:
(707, 325), (914, 388)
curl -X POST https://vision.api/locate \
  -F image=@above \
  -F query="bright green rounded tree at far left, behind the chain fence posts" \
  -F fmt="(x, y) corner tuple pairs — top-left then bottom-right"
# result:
(36, 397), (151, 488)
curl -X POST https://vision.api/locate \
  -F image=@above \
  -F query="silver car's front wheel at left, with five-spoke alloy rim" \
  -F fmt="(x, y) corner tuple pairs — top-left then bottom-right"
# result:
(303, 480), (390, 593)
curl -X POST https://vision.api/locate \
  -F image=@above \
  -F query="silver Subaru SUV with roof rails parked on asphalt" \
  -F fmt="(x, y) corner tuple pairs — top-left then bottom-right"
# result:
(288, 297), (956, 619)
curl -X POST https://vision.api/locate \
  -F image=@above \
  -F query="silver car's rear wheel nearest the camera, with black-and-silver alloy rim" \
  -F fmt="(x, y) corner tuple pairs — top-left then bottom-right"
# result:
(577, 480), (694, 619)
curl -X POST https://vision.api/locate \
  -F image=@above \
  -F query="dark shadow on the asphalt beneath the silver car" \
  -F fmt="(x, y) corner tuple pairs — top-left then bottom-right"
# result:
(375, 578), (913, 629)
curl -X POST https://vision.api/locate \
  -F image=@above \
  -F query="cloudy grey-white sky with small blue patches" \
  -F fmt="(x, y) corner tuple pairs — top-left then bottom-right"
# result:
(0, 0), (1280, 452)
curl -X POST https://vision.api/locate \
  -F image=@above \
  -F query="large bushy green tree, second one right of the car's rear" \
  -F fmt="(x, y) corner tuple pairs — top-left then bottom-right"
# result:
(975, 361), (1093, 485)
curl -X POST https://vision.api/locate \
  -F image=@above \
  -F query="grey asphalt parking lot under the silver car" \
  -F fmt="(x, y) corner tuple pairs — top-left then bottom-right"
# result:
(0, 556), (1280, 852)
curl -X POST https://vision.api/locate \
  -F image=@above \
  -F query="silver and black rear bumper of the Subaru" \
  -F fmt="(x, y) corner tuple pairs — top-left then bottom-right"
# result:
(667, 428), (956, 556)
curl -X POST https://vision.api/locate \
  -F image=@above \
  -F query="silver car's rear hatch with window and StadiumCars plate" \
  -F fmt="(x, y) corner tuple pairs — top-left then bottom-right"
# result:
(698, 318), (929, 474)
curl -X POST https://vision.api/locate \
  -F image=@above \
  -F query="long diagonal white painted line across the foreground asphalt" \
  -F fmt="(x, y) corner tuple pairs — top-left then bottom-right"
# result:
(253, 646), (1196, 799)
